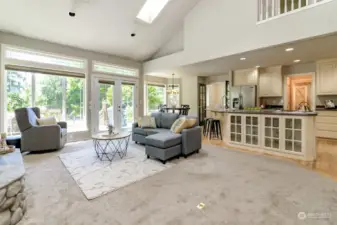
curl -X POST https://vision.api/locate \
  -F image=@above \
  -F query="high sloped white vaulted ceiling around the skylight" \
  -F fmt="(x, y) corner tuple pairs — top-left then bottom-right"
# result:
(0, 0), (200, 61)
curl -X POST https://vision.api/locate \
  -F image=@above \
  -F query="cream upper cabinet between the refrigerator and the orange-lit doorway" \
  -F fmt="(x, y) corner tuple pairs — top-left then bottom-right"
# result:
(258, 66), (283, 97)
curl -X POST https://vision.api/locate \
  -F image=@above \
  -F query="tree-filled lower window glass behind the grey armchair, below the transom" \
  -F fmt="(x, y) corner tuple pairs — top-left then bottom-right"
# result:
(6, 70), (86, 134)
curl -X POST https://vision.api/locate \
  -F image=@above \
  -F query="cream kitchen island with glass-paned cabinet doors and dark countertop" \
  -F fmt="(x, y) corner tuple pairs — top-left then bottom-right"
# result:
(209, 109), (317, 162)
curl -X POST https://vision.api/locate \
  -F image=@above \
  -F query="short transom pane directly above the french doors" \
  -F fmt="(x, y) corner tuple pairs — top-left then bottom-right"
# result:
(93, 62), (138, 77)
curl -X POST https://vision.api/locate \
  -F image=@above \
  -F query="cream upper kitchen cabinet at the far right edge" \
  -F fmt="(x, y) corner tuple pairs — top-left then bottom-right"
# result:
(316, 59), (337, 95)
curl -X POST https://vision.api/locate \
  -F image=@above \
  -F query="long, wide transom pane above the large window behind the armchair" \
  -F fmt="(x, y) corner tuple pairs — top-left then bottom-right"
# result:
(5, 47), (85, 69)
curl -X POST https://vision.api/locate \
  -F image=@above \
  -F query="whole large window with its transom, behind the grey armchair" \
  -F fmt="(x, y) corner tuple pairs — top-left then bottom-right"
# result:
(1, 46), (87, 134)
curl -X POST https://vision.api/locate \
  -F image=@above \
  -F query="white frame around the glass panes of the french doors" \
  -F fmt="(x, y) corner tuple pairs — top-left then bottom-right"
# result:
(90, 73), (139, 134)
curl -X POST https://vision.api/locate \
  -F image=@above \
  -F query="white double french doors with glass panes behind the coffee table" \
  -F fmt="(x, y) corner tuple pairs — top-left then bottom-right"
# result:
(91, 75), (138, 133)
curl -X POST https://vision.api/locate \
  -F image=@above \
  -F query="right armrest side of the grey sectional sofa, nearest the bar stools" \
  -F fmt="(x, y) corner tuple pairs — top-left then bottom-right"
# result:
(181, 126), (202, 155)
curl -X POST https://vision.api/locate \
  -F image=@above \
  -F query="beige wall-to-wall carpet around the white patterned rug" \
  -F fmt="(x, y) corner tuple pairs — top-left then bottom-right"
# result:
(20, 143), (337, 225)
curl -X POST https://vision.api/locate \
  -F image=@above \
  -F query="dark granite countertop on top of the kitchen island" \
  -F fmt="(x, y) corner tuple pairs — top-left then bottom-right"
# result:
(207, 109), (317, 116)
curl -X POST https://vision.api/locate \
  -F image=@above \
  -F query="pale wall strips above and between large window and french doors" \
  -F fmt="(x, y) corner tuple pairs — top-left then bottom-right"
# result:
(0, 32), (144, 140)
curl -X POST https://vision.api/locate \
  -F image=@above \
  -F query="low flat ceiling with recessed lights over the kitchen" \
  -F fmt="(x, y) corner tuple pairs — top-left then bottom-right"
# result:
(145, 33), (337, 78)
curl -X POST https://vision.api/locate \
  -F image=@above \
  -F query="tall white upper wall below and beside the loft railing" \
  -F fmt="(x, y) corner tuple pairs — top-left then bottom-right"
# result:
(144, 0), (337, 72)
